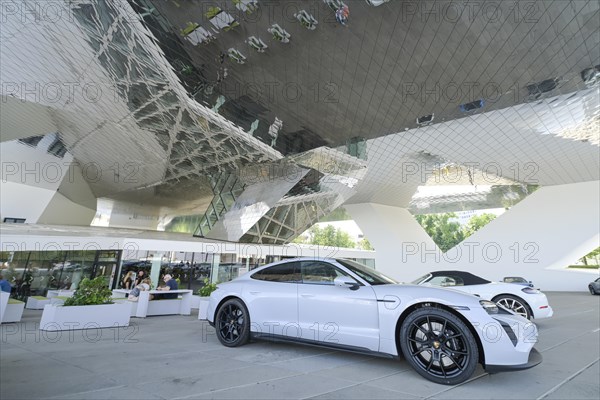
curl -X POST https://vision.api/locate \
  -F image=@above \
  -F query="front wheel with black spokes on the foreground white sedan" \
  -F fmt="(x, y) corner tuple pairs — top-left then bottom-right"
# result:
(400, 307), (479, 385)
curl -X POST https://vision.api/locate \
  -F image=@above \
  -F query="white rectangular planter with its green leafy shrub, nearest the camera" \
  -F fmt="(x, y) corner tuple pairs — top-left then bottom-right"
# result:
(40, 277), (131, 331)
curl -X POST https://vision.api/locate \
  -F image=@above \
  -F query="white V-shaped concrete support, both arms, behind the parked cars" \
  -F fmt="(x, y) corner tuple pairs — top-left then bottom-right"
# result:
(345, 181), (600, 291)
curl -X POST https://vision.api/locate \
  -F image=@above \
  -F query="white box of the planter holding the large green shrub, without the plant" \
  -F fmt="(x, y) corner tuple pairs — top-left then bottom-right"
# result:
(40, 303), (131, 331)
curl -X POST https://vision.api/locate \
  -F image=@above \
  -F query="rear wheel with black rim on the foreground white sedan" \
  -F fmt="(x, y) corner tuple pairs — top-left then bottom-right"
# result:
(215, 299), (250, 347)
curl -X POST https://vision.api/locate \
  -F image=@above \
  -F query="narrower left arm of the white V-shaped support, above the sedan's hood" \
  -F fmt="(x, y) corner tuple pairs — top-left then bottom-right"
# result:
(344, 203), (441, 282)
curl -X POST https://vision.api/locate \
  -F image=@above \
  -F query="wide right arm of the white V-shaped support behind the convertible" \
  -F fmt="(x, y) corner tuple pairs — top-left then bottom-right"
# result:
(436, 181), (600, 291)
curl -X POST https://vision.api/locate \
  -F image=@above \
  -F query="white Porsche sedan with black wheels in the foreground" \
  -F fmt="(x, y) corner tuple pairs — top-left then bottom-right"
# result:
(208, 258), (541, 385)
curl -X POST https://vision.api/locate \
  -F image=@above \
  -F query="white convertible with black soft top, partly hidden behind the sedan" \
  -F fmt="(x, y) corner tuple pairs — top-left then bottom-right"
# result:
(412, 271), (554, 319)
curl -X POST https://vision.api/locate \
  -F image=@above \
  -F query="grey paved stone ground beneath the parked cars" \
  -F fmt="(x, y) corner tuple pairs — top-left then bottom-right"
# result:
(0, 293), (600, 400)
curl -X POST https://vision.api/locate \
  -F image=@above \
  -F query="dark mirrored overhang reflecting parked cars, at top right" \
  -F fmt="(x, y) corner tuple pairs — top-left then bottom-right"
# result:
(146, 0), (600, 154)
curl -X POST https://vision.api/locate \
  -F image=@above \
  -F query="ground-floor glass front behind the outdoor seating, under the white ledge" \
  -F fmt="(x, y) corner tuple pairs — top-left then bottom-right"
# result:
(0, 250), (375, 300)
